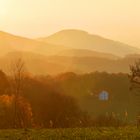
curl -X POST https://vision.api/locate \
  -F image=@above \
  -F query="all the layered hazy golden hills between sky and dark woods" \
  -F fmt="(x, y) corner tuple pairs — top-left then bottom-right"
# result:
(0, 30), (140, 75)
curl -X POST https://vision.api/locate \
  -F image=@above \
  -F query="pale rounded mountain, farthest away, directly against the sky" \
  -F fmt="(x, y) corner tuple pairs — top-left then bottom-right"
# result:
(38, 30), (140, 56)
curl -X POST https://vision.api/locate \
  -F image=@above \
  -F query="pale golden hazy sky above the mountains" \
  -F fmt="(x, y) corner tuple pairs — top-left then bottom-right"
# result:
(0, 0), (140, 47)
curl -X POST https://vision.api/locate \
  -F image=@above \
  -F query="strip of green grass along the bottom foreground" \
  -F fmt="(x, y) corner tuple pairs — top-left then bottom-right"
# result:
(0, 127), (140, 140)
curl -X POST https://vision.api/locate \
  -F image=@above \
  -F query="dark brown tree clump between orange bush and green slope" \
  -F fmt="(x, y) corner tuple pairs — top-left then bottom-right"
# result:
(23, 77), (88, 128)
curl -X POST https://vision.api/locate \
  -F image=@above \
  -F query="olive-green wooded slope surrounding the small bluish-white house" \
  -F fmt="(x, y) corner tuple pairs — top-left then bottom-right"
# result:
(43, 72), (136, 122)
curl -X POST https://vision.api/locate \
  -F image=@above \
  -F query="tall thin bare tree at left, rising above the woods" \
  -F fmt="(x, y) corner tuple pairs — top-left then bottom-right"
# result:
(11, 58), (25, 128)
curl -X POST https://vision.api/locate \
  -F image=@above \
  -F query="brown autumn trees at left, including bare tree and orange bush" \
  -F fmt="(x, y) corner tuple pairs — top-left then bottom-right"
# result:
(0, 68), (89, 128)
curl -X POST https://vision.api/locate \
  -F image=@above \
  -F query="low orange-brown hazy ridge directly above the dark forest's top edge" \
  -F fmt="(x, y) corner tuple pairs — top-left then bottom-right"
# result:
(0, 52), (140, 75)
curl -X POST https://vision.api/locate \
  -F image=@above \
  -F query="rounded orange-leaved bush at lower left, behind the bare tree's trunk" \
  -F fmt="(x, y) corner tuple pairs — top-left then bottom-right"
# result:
(0, 95), (32, 129)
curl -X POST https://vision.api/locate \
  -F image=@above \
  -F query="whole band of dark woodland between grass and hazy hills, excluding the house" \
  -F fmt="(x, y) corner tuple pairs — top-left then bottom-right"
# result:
(0, 59), (138, 128)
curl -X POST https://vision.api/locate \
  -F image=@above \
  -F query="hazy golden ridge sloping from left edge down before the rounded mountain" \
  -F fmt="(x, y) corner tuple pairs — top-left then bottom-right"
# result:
(0, 31), (120, 59)
